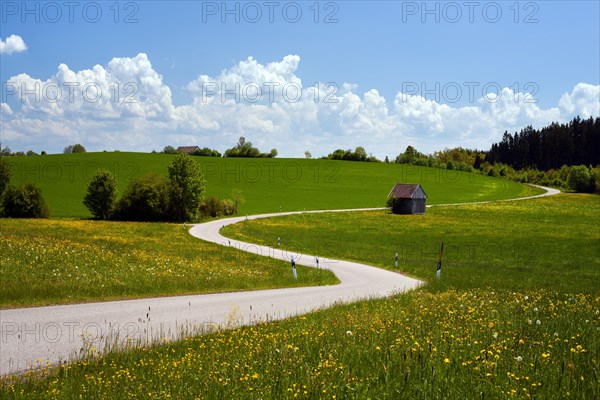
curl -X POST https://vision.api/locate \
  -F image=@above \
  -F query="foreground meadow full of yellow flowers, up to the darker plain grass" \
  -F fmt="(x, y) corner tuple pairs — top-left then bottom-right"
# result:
(0, 289), (600, 400)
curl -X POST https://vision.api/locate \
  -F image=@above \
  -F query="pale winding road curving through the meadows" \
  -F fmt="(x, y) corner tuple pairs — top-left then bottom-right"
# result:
(0, 188), (560, 375)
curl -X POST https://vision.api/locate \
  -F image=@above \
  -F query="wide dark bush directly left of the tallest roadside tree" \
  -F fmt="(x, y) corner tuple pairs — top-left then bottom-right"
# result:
(113, 174), (169, 221)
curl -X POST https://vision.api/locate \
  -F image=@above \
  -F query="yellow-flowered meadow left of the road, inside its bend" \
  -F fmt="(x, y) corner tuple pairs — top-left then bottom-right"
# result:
(0, 219), (338, 308)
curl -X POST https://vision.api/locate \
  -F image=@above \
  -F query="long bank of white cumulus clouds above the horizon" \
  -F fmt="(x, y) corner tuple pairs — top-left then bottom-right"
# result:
(1, 53), (600, 158)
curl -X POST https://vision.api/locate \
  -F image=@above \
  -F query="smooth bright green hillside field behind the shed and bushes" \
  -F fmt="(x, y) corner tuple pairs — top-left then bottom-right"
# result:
(5, 153), (541, 218)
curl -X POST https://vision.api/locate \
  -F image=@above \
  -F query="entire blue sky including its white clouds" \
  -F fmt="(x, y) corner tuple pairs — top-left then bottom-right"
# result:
(0, 1), (600, 158)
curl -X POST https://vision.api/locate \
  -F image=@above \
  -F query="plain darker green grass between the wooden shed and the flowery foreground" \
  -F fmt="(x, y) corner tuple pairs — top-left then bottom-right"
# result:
(223, 194), (600, 293)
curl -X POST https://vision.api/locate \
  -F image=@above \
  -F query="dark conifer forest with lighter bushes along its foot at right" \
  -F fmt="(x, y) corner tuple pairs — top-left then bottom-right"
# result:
(395, 117), (600, 193)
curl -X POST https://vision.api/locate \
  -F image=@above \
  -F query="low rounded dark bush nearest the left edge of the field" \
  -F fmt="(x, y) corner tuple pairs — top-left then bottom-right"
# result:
(2, 183), (50, 218)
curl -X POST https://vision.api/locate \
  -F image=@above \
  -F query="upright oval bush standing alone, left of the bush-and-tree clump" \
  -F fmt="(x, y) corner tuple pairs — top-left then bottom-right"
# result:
(83, 171), (117, 219)
